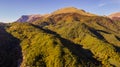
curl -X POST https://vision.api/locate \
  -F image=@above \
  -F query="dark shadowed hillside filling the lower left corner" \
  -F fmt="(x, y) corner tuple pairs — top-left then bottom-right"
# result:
(0, 27), (22, 67)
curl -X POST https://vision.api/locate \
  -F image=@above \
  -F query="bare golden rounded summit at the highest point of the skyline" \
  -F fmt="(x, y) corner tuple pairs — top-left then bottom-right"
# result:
(52, 7), (95, 16)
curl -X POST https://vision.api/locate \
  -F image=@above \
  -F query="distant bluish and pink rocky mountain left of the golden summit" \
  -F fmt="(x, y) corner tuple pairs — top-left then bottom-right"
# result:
(16, 14), (41, 23)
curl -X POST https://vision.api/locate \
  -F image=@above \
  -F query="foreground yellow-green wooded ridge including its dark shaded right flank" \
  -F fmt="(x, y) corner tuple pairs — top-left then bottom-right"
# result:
(7, 23), (100, 67)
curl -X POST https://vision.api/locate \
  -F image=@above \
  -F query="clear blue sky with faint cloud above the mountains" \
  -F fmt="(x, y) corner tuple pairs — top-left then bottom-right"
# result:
(0, 0), (120, 22)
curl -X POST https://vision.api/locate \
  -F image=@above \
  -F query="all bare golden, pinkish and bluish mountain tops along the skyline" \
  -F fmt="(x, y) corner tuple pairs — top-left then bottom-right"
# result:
(16, 7), (120, 23)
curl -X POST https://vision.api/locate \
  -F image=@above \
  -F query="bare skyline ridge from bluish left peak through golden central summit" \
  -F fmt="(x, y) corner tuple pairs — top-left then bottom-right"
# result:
(16, 7), (97, 23)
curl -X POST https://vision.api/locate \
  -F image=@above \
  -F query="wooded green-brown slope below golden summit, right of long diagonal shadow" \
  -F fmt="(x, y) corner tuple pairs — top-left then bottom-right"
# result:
(32, 13), (120, 66)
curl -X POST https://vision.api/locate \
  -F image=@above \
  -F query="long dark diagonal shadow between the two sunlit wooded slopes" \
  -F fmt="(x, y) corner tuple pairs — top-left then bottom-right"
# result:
(33, 25), (101, 66)
